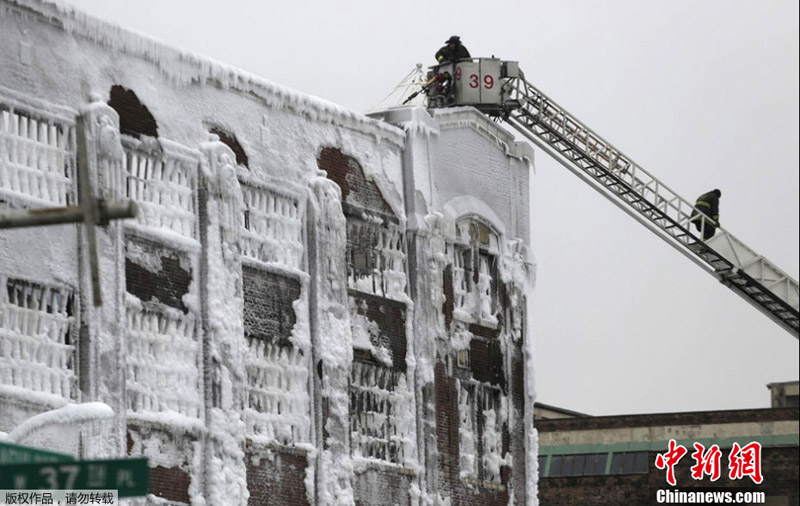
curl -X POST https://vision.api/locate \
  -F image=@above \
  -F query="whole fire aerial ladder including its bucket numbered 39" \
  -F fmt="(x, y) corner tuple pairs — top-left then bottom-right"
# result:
(416, 58), (800, 339)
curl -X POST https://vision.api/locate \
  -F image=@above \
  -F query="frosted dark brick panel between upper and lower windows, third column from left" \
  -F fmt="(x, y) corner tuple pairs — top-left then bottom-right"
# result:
(242, 266), (301, 346)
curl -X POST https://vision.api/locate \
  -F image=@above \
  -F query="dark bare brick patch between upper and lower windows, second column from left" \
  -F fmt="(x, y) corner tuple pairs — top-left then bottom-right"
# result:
(125, 238), (192, 313)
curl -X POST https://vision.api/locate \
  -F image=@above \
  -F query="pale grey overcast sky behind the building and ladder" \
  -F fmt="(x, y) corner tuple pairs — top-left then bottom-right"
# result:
(65, 0), (800, 415)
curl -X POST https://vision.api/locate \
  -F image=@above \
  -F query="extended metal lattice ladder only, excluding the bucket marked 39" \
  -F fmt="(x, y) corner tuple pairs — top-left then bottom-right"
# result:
(503, 74), (800, 339)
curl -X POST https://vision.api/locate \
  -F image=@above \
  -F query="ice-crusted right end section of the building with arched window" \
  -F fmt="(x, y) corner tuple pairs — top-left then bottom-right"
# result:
(376, 99), (535, 505)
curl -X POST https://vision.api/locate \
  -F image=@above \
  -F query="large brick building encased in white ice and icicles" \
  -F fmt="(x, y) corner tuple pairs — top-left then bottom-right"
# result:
(0, 0), (536, 506)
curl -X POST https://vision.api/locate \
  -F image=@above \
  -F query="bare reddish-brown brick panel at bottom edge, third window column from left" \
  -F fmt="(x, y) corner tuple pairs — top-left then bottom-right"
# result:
(246, 450), (309, 506)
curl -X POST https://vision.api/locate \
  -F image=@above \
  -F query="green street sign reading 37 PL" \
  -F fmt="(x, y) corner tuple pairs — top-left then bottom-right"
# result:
(0, 458), (149, 497)
